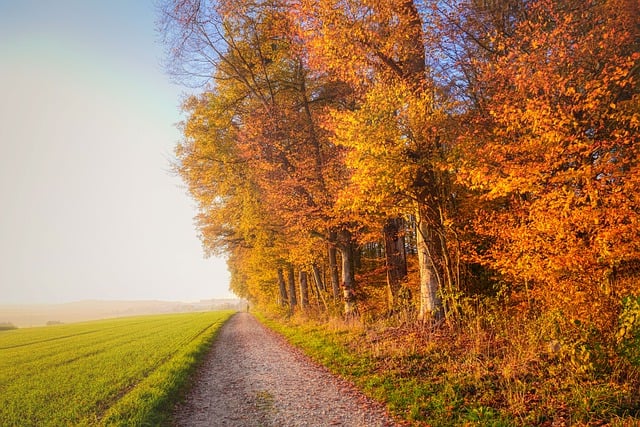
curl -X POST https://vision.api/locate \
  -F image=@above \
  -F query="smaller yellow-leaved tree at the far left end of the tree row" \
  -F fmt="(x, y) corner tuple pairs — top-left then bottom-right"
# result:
(176, 84), (292, 302)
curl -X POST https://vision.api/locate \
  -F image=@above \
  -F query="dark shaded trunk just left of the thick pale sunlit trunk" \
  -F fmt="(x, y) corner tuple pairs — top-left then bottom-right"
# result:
(383, 218), (407, 310)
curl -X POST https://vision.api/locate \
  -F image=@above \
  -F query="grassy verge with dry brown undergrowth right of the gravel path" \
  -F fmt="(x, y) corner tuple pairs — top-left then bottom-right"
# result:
(259, 309), (640, 426)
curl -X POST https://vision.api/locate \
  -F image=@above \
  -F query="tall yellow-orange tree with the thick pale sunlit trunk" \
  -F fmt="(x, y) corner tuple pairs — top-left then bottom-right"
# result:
(299, 0), (468, 318)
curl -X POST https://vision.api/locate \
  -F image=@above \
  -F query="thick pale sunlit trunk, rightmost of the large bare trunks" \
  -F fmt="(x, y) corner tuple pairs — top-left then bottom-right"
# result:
(416, 209), (442, 321)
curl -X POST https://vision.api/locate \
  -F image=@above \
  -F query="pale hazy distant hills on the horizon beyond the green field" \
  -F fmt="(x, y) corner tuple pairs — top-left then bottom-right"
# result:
(0, 299), (246, 327)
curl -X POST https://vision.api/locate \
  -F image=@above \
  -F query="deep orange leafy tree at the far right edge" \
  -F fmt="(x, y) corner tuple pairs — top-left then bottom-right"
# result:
(460, 0), (640, 323)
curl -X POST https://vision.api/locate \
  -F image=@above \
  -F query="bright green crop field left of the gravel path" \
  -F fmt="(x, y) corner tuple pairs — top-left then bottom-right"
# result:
(0, 311), (233, 426)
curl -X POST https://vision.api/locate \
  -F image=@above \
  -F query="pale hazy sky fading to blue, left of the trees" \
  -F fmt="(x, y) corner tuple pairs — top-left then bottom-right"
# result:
(0, 0), (232, 304)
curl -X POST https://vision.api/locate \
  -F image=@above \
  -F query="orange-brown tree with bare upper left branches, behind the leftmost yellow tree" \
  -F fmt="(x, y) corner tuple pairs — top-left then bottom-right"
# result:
(164, 0), (362, 313)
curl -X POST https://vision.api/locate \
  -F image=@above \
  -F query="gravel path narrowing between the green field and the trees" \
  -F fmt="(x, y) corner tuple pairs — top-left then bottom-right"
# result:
(174, 313), (396, 427)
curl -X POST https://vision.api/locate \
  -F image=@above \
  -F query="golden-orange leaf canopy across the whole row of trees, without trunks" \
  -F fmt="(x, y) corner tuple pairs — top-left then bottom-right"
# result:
(166, 0), (640, 320)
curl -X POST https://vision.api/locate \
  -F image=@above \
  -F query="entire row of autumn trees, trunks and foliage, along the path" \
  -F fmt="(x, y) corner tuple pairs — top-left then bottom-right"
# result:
(161, 0), (640, 331)
